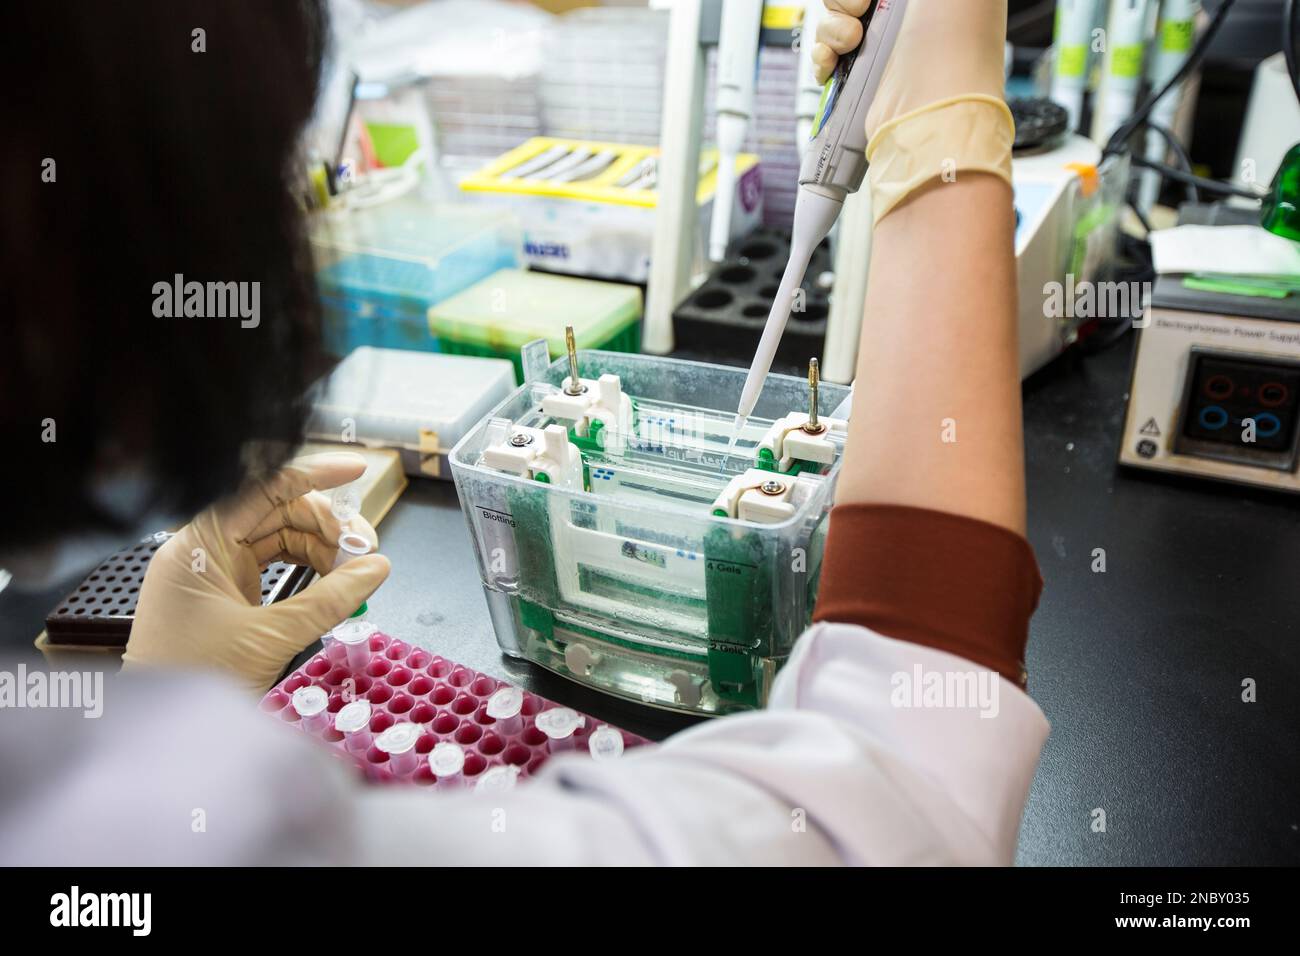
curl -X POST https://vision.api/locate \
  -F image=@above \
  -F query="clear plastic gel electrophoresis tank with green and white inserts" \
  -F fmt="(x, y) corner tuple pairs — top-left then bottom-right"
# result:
(451, 351), (849, 714)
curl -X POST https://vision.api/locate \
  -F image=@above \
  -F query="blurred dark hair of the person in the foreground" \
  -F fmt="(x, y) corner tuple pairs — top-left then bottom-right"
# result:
(0, 0), (328, 546)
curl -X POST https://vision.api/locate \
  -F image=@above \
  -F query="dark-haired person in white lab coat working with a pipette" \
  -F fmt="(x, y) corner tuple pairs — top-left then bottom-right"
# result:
(0, 0), (1048, 864)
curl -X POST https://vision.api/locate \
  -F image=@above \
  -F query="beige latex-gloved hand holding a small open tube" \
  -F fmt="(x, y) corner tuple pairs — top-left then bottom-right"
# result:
(122, 453), (389, 693)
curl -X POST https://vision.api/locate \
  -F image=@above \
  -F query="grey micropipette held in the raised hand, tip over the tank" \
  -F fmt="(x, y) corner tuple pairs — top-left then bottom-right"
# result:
(728, 0), (907, 434)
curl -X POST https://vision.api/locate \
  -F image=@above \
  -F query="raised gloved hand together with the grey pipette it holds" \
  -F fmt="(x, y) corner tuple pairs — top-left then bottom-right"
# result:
(737, 0), (1015, 428)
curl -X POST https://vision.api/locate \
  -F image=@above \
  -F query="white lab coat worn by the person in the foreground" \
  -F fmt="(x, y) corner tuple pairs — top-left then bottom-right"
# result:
(0, 624), (1048, 865)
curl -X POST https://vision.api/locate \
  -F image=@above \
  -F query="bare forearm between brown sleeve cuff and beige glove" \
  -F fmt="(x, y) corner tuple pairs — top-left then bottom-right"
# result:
(836, 173), (1024, 535)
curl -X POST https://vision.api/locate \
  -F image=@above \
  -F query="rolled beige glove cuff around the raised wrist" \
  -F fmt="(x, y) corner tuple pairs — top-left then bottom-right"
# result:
(866, 94), (1015, 222)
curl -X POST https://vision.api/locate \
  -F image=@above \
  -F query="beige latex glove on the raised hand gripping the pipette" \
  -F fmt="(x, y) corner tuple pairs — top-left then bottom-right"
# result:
(811, 0), (1015, 222)
